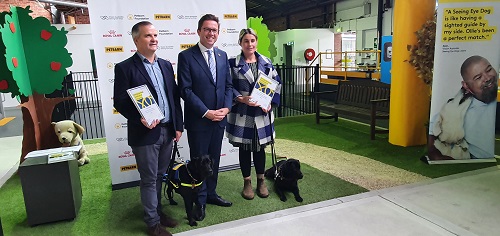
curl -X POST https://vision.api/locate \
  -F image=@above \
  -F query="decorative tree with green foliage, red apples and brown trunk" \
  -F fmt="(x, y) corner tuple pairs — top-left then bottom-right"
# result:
(0, 6), (74, 161)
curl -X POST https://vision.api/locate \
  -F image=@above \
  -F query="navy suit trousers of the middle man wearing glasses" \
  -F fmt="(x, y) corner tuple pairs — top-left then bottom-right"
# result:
(187, 125), (224, 205)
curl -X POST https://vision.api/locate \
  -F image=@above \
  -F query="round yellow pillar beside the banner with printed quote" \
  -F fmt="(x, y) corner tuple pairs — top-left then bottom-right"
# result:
(389, 0), (436, 147)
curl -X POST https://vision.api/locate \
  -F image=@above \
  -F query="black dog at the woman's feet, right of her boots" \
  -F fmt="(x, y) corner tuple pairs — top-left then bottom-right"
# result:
(264, 158), (304, 202)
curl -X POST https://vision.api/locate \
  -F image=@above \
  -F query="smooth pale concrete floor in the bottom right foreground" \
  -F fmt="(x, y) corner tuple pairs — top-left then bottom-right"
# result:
(176, 167), (500, 236)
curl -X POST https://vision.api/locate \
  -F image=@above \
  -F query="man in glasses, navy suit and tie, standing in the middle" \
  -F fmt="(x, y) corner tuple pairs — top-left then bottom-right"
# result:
(177, 14), (233, 221)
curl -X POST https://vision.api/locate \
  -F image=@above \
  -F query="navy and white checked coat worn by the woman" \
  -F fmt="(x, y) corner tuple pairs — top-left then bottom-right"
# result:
(226, 52), (281, 145)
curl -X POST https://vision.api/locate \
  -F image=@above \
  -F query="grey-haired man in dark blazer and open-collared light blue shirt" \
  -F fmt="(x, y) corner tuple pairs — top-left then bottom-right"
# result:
(113, 21), (184, 235)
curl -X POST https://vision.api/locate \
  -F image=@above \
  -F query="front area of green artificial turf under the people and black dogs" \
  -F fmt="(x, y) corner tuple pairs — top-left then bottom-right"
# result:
(0, 154), (366, 235)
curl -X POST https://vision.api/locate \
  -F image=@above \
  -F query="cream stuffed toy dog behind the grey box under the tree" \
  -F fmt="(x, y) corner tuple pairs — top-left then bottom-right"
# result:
(52, 120), (90, 166)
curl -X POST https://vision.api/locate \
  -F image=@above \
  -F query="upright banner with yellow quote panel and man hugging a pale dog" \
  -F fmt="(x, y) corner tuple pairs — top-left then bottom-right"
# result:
(426, 0), (500, 164)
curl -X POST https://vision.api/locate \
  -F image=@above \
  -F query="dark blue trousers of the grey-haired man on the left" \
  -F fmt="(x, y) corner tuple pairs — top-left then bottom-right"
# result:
(132, 127), (175, 227)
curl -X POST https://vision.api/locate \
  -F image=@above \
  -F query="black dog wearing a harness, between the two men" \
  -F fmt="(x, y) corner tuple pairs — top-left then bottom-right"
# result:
(167, 155), (213, 226)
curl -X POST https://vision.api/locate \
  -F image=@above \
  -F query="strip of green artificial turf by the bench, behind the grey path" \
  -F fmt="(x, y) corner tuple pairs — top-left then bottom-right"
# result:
(276, 115), (500, 178)
